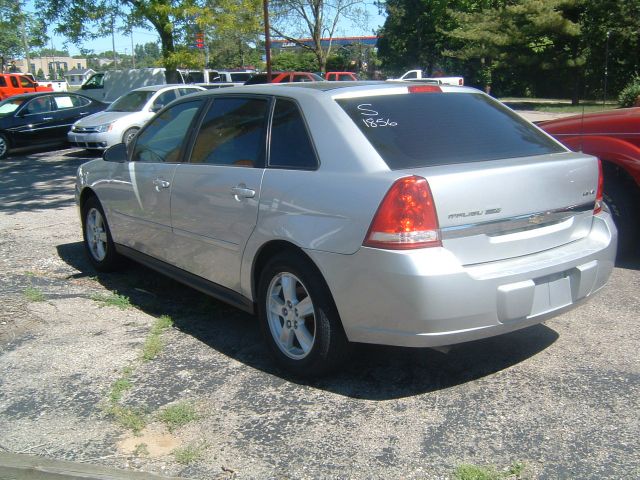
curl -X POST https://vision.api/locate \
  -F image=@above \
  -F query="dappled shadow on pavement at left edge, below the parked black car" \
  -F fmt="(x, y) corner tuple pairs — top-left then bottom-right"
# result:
(0, 147), (95, 214)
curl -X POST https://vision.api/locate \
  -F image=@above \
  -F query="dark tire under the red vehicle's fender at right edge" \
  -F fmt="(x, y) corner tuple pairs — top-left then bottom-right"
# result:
(603, 171), (640, 258)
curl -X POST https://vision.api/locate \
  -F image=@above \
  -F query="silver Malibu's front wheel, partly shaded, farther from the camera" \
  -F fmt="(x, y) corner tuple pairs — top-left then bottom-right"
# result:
(82, 197), (121, 272)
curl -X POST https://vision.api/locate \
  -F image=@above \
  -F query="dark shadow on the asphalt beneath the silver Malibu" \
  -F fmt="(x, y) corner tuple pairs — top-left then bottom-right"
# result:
(58, 242), (558, 400)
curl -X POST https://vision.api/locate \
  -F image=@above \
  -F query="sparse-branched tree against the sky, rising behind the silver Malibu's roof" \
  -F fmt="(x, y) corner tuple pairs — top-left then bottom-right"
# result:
(271, 0), (366, 72)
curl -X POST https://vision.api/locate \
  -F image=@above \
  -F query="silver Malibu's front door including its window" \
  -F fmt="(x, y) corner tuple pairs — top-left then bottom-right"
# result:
(100, 100), (204, 261)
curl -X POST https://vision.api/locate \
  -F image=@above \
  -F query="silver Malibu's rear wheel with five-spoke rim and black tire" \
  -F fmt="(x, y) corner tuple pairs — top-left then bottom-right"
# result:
(258, 254), (349, 376)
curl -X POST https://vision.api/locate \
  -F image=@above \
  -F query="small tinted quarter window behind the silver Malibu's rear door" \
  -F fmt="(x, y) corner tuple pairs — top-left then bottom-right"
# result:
(269, 99), (318, 170)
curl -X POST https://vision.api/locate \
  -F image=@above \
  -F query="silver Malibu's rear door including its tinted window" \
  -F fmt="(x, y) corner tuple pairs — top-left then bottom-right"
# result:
(171, 95), (271, 291)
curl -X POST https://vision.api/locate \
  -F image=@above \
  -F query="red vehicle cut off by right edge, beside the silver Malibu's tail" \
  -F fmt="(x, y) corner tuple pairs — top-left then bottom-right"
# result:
(538, 108), (640, 255)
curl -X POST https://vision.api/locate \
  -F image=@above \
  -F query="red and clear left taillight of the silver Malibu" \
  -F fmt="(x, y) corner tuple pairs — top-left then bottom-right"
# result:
(364, 176), (442, 250)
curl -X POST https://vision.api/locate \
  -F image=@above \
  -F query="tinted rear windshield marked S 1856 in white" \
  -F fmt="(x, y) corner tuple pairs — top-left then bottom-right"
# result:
(337, 93), (564, 170)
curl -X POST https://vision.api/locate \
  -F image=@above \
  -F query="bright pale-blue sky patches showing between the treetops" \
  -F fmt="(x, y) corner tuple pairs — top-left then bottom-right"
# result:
(27, 0), (384, 55)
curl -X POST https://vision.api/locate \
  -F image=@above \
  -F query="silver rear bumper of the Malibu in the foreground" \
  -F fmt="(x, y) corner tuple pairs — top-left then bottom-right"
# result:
(307, 213), (617, 347)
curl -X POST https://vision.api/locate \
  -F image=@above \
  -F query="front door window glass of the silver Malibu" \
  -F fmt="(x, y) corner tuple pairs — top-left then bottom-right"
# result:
(131, 101), (202, 163)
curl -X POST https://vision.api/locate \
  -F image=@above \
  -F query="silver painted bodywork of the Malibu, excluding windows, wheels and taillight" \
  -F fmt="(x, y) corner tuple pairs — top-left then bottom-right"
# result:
(77, 84), (617, 346)
